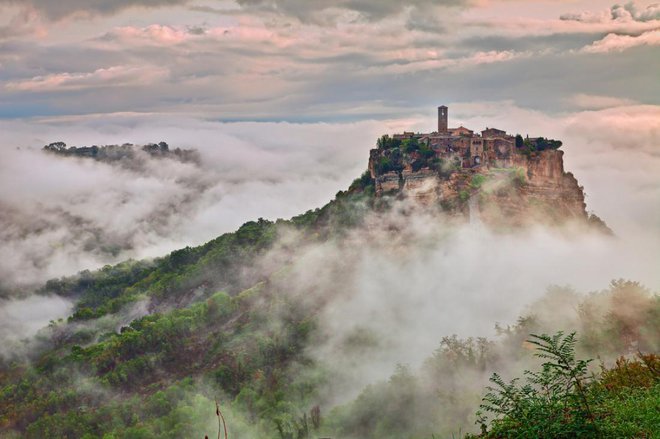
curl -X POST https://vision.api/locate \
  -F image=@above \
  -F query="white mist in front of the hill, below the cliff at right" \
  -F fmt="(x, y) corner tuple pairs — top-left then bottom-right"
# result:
(278, 211), (660, 402)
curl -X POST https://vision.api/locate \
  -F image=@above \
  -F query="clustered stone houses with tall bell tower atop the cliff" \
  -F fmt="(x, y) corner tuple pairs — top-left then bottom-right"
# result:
(393, 105), (516, 168)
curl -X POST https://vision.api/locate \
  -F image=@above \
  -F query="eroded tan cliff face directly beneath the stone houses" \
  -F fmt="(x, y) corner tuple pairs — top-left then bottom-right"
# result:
(369, 150), (588, 227)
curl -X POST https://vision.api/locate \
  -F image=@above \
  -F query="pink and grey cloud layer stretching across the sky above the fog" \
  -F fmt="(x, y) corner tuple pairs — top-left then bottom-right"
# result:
(0, 2), (658, 121)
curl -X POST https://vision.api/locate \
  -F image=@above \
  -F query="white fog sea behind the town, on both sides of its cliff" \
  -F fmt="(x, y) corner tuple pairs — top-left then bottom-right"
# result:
(0, 102), (660, 292)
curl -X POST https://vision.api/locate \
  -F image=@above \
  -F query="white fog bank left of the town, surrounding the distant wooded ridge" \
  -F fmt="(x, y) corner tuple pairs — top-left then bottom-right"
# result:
(0, 115), (412, 287)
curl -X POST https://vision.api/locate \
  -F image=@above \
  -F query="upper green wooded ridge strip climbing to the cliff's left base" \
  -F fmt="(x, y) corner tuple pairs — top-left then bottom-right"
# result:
(40, 182), (374, 326)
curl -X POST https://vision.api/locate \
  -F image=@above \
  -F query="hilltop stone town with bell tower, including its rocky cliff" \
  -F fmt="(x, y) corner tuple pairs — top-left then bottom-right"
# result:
(369, 105), (589, 226)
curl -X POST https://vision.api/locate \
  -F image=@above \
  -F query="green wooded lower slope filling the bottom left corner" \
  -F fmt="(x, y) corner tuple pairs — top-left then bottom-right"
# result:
(0, 286), (323, 438)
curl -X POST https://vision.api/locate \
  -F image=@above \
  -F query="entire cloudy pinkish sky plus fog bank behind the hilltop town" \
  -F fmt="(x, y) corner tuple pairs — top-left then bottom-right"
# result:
(0, 0), (660, 289)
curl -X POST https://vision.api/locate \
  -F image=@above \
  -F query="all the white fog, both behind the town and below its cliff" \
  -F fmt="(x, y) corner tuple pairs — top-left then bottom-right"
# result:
(0, 102), (660, 376)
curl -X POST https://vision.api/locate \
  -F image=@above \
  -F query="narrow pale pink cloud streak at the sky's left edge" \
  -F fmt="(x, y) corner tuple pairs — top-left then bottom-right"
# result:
(5, 66), (169, 92)
